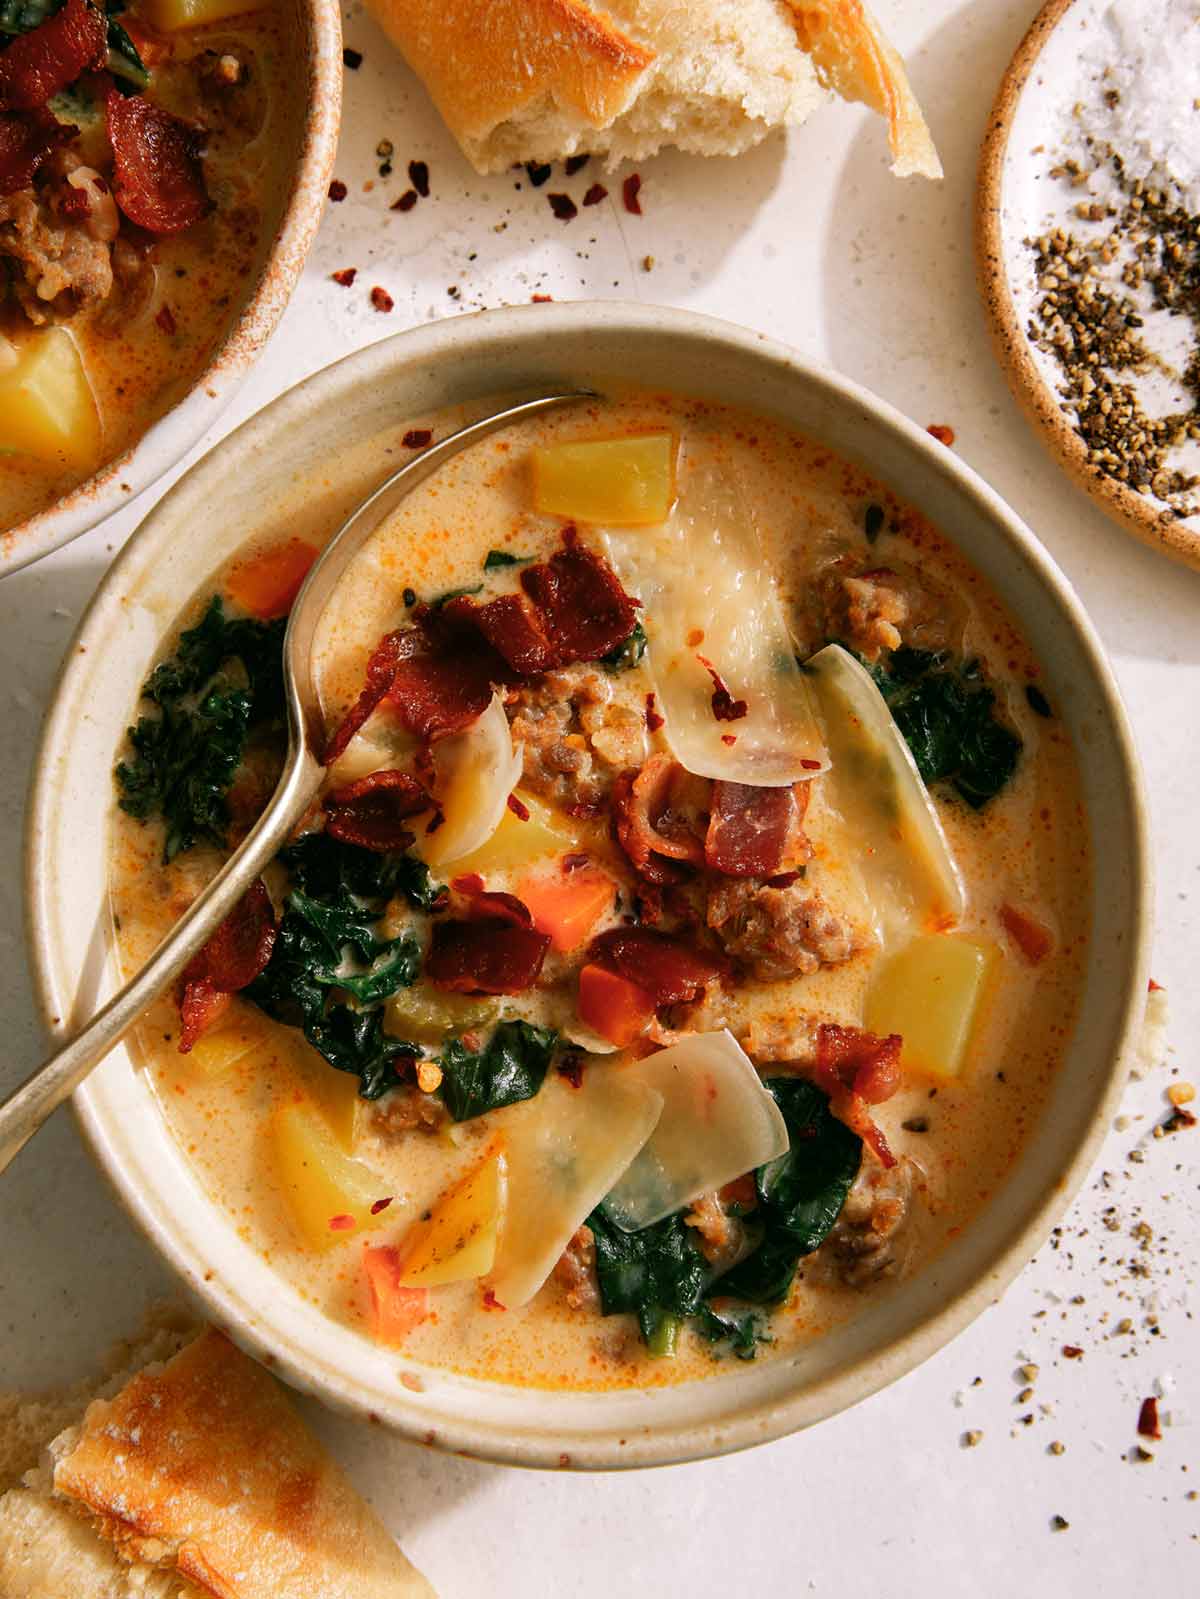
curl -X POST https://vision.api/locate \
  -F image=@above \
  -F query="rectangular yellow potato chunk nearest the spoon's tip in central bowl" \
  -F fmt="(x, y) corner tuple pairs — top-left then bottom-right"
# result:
(533, 433), (675, 528)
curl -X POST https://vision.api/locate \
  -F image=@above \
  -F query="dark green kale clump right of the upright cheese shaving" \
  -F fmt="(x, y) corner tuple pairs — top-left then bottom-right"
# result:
(872, 648), (1021, 811)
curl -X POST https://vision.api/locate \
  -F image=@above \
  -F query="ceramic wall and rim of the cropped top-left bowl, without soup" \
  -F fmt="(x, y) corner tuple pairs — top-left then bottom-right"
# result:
(0, 0), (342, 574)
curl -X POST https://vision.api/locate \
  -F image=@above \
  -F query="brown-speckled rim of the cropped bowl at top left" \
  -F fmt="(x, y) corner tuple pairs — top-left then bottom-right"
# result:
(0, 0), (342, 576)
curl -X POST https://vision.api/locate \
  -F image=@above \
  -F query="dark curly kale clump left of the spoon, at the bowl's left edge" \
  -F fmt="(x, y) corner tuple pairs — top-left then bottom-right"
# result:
(115, 595), (285, 860)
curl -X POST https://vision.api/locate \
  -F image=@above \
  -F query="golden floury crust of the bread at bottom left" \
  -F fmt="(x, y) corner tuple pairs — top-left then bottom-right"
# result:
(54, 1329), (432, 1599)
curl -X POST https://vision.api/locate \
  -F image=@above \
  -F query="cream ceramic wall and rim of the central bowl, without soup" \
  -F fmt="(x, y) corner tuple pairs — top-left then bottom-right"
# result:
(26, 304), (1150, 1468)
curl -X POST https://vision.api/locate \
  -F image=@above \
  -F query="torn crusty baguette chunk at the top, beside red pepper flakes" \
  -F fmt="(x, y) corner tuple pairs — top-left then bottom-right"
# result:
(368, 0), (941, 177)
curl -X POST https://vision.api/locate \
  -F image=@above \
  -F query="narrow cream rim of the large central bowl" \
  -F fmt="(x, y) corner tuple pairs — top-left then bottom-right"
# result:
(24, 301), (1154, 1469)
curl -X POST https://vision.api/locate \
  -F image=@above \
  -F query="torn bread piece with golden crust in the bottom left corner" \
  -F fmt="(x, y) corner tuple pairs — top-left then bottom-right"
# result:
(0, 1329), (432, 1599)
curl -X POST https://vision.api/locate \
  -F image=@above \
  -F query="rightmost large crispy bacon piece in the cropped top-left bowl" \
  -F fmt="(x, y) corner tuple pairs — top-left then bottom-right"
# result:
(104, 90), (211, 233)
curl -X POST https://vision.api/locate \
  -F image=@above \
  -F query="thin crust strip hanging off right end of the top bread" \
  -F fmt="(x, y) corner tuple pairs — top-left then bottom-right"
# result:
(786, 0), (942, 177)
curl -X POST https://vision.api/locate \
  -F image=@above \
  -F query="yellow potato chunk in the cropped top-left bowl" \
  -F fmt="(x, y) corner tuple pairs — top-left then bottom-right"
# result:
(0, 328), (101, 470)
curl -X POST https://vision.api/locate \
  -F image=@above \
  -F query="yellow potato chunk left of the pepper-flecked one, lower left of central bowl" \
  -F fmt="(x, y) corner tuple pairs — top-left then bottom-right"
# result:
(267, 1100), (389, 1249)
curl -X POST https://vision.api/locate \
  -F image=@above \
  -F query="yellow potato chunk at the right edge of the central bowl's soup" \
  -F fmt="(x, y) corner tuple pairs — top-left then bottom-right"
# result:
(866, 932), (998, 1078)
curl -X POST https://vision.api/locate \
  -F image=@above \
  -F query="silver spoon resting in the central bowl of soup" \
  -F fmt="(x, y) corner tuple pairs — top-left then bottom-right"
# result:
(0, 389), (595, 1172)
